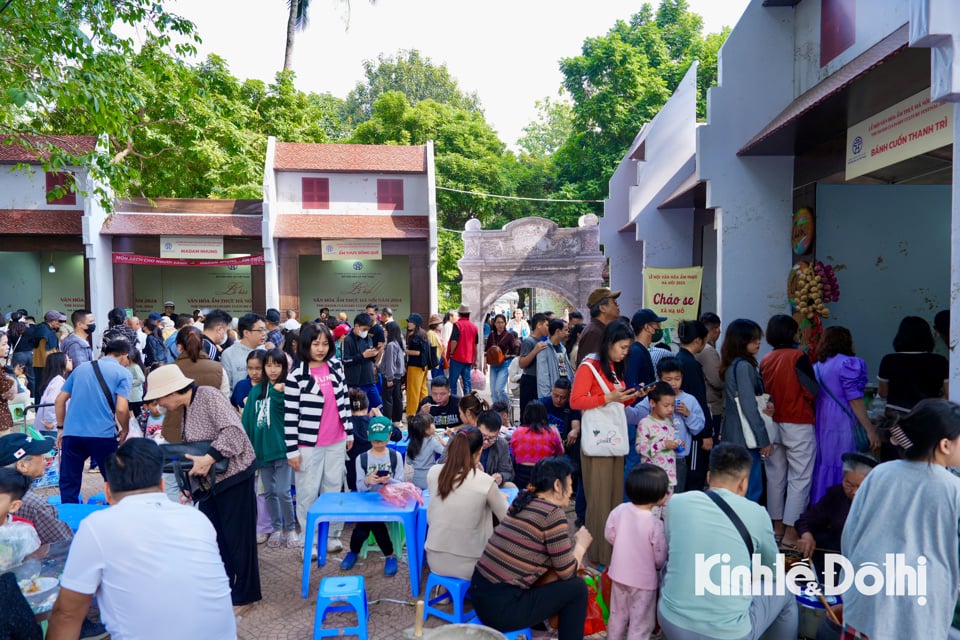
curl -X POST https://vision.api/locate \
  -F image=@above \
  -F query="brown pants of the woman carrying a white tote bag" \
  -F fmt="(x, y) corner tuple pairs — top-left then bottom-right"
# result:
(580, 451), (623, 565)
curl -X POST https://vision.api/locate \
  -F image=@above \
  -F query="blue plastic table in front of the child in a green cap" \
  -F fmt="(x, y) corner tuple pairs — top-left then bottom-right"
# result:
(300, 492), (423, 598)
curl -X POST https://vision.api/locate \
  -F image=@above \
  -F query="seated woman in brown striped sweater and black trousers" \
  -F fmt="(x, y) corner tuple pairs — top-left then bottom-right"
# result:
(470, 458), (593, 640)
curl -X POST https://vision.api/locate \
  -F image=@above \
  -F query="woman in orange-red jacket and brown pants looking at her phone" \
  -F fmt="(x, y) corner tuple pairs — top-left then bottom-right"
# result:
(570, 320), (640, 565)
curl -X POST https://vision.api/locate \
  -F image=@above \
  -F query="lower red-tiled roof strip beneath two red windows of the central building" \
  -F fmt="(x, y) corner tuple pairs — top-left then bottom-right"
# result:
(274, 213), (430, 240)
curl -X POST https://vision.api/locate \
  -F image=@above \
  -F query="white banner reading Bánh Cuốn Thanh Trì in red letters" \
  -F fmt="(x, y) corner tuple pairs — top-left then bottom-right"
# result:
(846, 89), (953, 180)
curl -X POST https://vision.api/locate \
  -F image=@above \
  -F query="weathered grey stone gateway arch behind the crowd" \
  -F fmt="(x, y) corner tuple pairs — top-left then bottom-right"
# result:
(457, 214), (606, 335)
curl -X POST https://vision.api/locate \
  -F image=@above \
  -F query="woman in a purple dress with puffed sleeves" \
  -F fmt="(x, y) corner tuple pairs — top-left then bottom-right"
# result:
(810, 327), (880, 504)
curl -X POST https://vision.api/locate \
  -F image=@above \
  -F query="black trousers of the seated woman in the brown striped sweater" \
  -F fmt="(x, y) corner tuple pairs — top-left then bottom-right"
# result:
(470, 570), (587, 640)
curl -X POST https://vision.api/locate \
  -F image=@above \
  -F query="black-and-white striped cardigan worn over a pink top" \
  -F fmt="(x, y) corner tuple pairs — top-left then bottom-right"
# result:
(283, 358), (353, 458)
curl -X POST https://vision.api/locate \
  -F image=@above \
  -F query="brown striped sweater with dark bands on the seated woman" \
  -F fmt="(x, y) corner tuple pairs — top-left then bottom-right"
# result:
(477, 498), (577, 589)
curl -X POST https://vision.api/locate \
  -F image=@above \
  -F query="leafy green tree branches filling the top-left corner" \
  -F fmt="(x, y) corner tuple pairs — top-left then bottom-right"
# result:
(0, 0), (199, 202)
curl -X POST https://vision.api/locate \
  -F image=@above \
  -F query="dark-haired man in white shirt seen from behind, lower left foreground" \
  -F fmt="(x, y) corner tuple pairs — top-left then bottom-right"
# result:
(46, 438), (237, 640)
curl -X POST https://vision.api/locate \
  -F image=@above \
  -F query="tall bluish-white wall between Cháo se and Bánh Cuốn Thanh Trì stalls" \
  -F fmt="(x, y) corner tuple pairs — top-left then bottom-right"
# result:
(697, 0), (794, 330)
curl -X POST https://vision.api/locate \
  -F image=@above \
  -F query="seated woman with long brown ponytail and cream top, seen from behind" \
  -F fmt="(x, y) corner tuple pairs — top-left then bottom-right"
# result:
(425, 427), (507, 580)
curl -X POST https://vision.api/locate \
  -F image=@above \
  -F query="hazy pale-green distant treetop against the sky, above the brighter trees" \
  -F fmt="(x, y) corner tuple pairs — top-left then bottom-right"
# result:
(346, 49), (481, 124)
